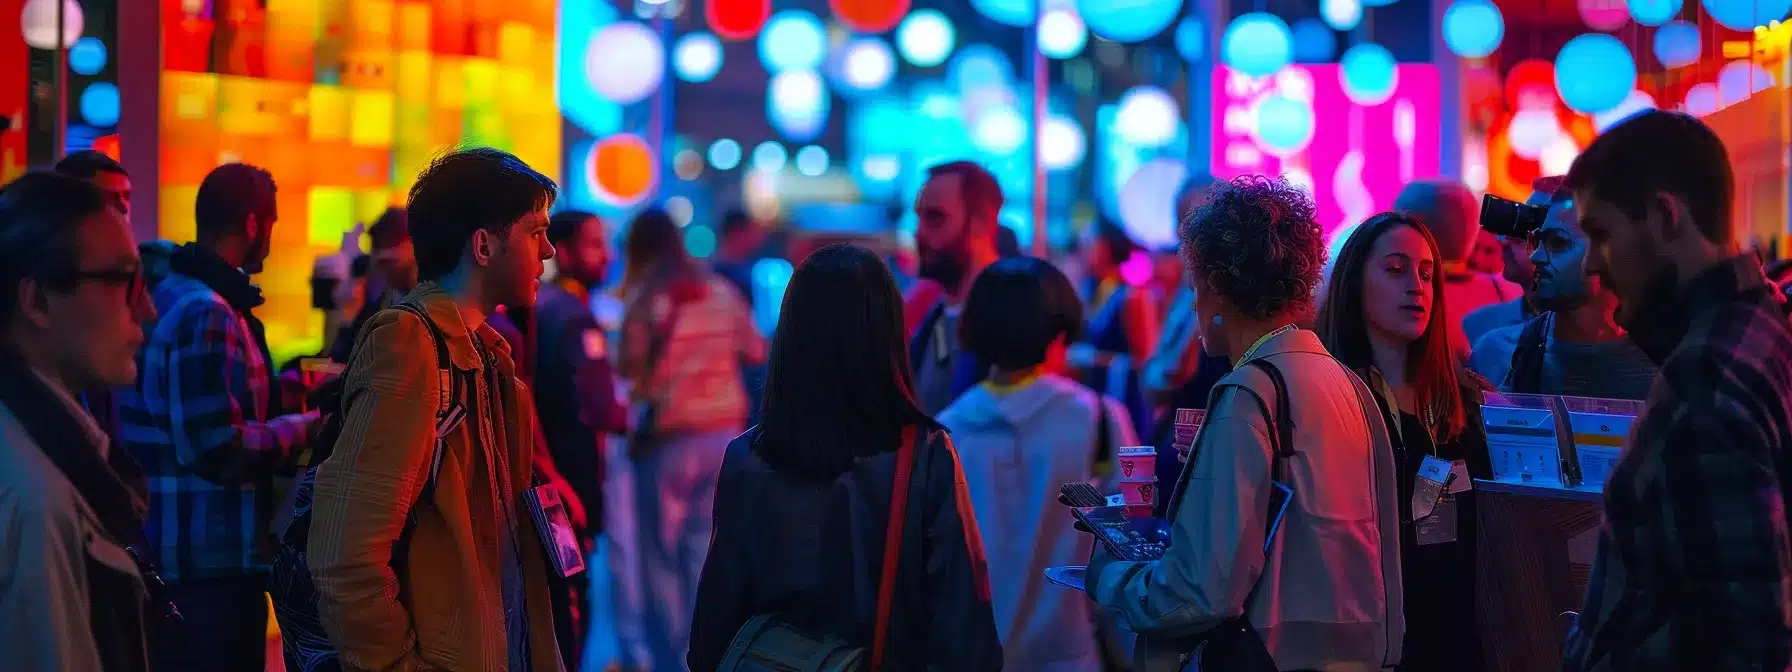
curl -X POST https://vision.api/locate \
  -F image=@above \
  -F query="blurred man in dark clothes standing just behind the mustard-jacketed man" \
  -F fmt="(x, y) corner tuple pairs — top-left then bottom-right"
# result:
(530, 210), (629, 665)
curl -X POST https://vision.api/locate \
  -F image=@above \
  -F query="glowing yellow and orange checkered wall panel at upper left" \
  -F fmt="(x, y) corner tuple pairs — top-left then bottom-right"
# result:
(159, 0), (561, 358)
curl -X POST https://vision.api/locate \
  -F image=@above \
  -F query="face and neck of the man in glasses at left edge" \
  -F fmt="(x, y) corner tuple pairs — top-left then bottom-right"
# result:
(34, 208), (156, 389)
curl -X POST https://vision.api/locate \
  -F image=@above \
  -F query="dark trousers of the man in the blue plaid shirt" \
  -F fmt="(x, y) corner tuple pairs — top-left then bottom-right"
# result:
(152, 575), (267, 672)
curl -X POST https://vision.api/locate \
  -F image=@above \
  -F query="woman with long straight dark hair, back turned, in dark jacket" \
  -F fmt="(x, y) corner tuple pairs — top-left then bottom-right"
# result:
(688, 244), (1002, 670)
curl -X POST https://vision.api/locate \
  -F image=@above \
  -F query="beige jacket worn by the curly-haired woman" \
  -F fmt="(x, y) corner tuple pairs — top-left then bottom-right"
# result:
(1095, 330), (1405, 672)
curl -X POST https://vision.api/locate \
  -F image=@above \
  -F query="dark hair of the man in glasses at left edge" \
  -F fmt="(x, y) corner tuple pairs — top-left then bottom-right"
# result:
(0, 170), (109, 326)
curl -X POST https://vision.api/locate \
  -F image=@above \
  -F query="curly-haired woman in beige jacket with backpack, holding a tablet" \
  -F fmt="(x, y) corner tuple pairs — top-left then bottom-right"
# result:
(1088, 177), (1403, 672)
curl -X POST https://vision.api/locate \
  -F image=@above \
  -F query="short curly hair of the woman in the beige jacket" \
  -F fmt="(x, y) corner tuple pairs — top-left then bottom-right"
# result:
(1179, 176), (1326, 323)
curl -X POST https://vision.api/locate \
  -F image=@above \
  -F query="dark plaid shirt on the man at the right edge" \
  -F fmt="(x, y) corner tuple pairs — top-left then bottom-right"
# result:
(1564, 256), (1792, 670)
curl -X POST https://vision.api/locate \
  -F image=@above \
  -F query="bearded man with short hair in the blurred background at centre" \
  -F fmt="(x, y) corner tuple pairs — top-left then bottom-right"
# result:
(909, 161), (1002, 414)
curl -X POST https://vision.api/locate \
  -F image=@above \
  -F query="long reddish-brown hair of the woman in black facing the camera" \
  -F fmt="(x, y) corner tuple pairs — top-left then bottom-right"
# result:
(1315, 211), (1468, 441)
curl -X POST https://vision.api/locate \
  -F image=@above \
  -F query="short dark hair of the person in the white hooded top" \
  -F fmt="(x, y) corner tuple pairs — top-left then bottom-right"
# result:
(959, 256), (1082, 371)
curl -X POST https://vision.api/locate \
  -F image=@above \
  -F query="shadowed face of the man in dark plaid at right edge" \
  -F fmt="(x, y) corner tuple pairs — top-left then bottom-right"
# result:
(1573, 190), (1677, 330)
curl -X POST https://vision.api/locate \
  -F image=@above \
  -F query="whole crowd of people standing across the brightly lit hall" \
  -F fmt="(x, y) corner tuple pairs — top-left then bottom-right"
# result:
(0, 111), (1792, 672)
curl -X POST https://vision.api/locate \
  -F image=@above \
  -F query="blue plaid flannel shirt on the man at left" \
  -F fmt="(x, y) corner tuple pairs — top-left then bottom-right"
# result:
(118, 274), (314, 581)
